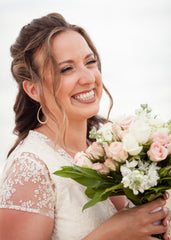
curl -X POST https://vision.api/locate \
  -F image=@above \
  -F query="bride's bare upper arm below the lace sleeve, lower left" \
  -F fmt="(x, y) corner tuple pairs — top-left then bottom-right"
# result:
(0, 209), (54, 240)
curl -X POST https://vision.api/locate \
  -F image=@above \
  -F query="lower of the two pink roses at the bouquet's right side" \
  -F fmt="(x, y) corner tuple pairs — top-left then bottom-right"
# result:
(147, 142), (168, 162)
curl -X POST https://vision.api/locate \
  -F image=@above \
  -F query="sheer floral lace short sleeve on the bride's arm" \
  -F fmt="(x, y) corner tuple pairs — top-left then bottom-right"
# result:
(0, 153), (55, 218)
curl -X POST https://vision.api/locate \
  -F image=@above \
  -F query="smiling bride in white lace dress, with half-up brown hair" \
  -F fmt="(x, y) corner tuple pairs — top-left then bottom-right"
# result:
(0, 13), (170, 240)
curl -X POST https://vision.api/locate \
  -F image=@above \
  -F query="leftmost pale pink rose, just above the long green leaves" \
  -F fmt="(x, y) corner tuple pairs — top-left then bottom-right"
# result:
(73, 151), (93, 168)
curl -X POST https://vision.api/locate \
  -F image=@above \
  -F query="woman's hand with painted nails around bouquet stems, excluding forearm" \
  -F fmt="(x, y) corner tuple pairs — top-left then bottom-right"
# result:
(111, 199), (168, 240)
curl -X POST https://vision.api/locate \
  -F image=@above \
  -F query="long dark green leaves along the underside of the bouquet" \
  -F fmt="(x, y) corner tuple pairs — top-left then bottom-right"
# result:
(54, 165), (171, 210)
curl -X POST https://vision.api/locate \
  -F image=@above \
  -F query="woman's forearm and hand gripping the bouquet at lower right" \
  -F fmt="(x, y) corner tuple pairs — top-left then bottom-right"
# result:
(82, 198), (168, 240)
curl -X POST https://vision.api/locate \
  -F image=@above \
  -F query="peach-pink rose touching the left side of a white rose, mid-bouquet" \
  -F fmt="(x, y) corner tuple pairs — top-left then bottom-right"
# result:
(103, 142), (128, 162)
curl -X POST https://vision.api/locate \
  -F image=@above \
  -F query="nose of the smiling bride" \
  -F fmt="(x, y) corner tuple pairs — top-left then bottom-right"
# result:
(79, 66), (95, 84)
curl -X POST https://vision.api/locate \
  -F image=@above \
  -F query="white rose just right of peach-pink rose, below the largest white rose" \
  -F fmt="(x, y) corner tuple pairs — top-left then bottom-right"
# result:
(123, 133), (142, 156)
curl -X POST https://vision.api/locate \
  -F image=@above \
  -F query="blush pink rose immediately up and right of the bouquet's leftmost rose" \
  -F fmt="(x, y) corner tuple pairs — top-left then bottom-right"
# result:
(86, 142), (104, 159)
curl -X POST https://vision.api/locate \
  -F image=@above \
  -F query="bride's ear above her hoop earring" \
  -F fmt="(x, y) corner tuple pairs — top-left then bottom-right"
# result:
(23, 80), (40, 102)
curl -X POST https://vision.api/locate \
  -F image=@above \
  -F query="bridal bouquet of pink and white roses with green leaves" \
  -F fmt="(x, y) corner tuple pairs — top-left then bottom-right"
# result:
(55, 104), (171, 239)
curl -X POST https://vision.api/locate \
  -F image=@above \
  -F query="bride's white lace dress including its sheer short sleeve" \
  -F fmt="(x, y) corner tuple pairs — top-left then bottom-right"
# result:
(0, 131), (116, 240)
